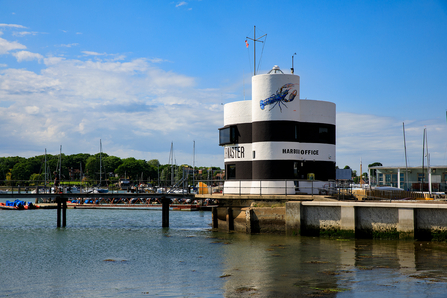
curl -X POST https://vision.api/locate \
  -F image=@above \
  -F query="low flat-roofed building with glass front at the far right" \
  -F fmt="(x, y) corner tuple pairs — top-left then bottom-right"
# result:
(368, 166), (447, 192)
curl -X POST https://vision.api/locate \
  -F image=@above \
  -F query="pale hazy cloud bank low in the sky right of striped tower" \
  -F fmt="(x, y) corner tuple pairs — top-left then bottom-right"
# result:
(336, 113), (447, 171)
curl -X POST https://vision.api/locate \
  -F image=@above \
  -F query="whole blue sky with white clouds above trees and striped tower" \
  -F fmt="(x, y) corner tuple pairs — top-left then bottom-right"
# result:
(0, 0), (447, 170)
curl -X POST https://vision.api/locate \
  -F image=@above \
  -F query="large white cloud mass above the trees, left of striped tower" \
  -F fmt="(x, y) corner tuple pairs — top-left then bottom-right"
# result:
(0, 48), (223, 166)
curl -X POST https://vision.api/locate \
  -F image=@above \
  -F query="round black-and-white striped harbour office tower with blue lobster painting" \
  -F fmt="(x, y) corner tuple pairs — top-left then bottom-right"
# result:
(219, 65), (335, 194)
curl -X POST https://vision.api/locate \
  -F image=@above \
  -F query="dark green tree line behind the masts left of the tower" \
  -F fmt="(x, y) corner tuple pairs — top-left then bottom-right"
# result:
(0, 153), (222, 185)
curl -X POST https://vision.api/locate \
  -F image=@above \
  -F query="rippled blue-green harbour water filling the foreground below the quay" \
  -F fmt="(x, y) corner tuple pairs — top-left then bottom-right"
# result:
(0, 197), (447, 298)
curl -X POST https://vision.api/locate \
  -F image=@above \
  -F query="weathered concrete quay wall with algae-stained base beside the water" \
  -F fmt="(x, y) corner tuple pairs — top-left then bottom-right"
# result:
(213, 201), (447, 240)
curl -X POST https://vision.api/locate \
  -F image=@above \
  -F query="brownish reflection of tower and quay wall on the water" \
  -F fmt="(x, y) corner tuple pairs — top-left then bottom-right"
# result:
(214, 234), (447, 297)
